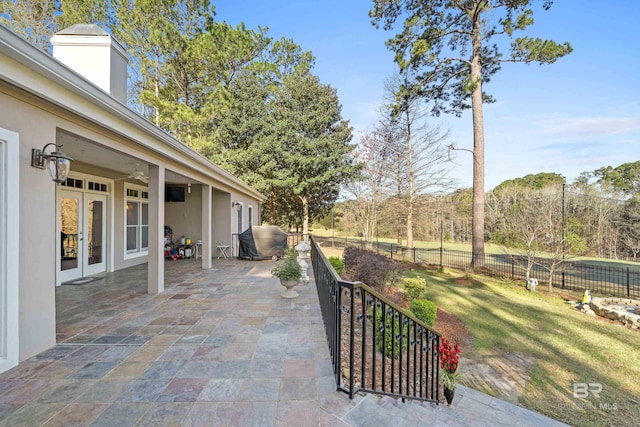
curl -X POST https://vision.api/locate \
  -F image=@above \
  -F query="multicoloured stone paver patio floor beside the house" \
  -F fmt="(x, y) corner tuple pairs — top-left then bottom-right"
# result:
(0, 259), (568, 427)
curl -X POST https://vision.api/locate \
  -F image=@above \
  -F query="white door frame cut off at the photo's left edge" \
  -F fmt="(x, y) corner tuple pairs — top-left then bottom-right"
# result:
(0, 128), (20, 372)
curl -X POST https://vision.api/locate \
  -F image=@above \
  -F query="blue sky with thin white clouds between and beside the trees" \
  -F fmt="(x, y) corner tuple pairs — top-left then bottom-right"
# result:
(214, 0), (640, 190)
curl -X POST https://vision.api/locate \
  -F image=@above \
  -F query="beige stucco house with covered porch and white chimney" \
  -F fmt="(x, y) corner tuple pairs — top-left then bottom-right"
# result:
(0, 25), (264, 372)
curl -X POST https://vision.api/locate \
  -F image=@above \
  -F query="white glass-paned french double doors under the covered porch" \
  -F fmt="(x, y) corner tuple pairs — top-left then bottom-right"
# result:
(58, 189), (107, 283)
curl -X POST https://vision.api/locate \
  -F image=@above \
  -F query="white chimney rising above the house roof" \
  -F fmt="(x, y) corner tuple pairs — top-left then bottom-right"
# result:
(51, 24), (128, 104)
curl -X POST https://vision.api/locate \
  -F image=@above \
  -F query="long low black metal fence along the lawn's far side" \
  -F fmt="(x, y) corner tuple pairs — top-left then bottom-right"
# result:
(314, 236), (640, 298)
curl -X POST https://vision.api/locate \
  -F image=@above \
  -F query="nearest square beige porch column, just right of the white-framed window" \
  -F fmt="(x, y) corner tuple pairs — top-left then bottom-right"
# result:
(147, 165), (165, 294)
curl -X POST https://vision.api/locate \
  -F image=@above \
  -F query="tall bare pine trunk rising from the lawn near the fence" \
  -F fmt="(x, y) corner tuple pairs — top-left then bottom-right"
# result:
(471, 14), (484, 268)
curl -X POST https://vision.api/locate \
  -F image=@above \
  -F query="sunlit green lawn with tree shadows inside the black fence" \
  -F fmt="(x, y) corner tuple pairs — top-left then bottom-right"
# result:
(409, 270), (640, 426)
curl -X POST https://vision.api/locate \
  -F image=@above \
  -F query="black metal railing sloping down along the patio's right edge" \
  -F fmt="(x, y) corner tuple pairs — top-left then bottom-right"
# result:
(311, 238), (441, 402)
